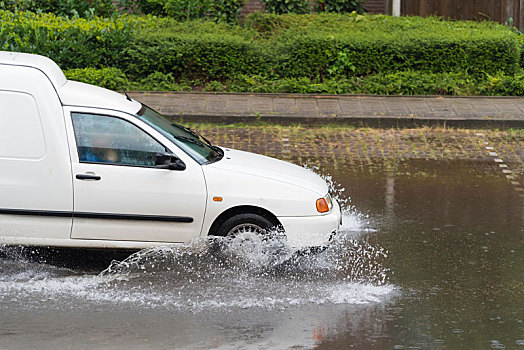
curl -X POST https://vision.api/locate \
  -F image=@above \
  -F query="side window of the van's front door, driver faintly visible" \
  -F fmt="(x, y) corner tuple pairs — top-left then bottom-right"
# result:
(71, 113), (166, 167)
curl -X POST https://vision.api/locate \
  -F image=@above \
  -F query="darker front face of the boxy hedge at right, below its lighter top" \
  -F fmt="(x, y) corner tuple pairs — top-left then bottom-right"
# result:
(275, 33), (519, 78)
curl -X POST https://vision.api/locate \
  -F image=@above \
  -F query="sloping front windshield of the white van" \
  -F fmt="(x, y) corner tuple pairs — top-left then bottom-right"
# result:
(137, 105), (224, 165)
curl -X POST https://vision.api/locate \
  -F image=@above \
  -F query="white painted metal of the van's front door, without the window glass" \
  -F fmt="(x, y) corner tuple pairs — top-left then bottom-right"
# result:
(64, 107), (207, 242)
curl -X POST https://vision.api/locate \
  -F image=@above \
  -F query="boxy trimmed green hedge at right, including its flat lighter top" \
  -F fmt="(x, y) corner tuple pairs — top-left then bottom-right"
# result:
(267, 14), (520, 78)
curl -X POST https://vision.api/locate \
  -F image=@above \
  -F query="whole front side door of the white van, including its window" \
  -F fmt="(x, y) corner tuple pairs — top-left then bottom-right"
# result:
(66, 109), (206, 242)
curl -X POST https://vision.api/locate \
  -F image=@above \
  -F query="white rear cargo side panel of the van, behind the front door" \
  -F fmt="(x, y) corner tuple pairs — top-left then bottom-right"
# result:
(0, 64), (73, 245)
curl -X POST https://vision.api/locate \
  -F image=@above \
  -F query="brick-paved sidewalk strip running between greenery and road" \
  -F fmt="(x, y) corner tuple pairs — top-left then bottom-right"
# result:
(129, 92), (524, 127)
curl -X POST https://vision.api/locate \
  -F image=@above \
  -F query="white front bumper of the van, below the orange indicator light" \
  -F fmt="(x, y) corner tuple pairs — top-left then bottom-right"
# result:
(278, 201), (342, 248)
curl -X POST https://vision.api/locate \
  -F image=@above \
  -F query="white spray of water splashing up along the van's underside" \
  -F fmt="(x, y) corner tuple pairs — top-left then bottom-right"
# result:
(0, 169), (395, 312)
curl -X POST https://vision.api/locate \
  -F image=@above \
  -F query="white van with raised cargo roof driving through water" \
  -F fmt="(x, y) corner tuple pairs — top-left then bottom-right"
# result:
(0, 52), (341, 249)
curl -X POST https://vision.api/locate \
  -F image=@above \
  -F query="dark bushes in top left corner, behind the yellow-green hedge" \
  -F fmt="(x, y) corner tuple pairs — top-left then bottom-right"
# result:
(0, 0), (116, 17)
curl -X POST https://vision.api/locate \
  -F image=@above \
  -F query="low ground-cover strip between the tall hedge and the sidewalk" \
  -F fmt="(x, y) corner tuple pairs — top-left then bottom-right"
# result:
(60, 68), (524, 96)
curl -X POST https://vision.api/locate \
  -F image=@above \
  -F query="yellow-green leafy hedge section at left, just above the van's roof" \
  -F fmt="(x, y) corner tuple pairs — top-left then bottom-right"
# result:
(0, 11), (132, 69)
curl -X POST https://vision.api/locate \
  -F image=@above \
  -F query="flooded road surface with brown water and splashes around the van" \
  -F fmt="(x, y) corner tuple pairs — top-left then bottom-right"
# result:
(0, 161), (524, 349)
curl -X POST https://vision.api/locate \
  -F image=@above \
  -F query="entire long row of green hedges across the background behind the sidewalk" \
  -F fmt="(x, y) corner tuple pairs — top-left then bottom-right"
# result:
(0, 11), (522, 94)
